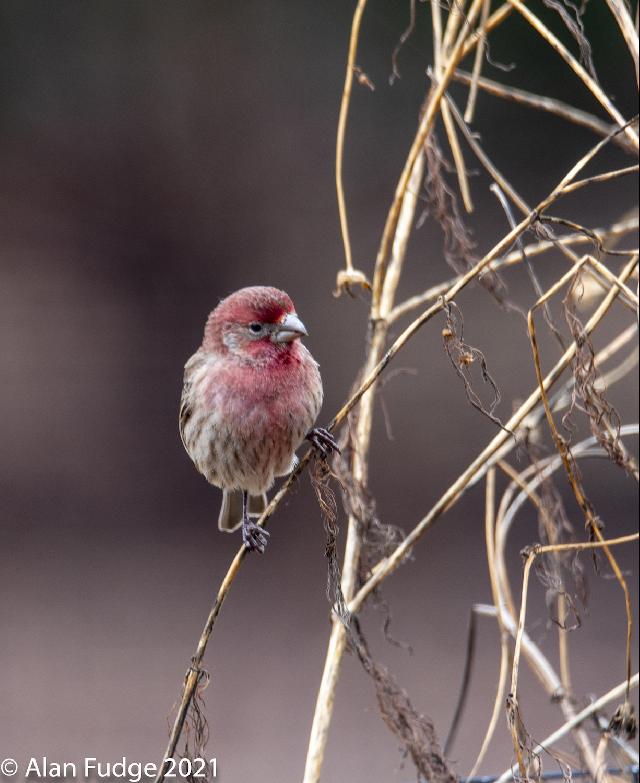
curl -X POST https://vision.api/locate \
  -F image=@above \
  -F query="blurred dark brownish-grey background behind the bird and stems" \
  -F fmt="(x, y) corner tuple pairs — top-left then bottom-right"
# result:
(0, 0), (638, 783)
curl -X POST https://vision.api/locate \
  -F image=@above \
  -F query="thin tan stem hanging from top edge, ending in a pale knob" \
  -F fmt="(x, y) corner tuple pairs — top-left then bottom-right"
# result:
(336, 0), (367, 293)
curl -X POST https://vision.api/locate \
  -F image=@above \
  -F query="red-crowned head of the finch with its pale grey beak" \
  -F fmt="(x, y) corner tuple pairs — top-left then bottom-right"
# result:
(202, 286), (307, 359)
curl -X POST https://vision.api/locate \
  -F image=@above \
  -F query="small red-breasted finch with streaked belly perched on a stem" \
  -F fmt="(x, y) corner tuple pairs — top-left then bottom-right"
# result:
(180, 286), (338, 553)
